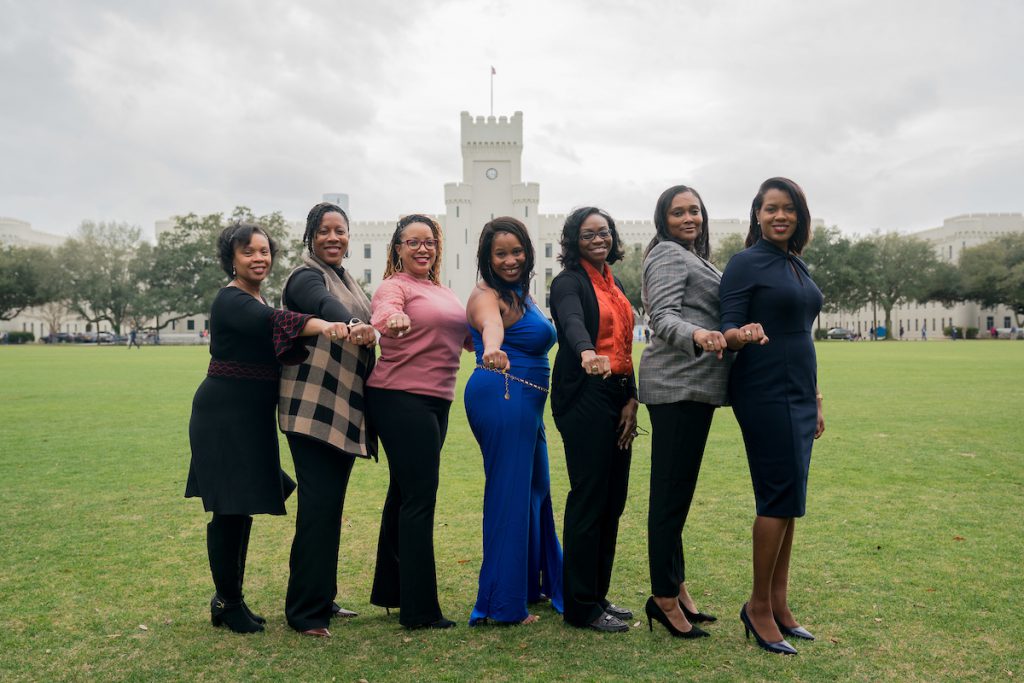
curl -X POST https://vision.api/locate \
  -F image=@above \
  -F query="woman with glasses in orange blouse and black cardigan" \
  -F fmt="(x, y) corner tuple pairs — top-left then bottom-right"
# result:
(551, 207), (638, 632)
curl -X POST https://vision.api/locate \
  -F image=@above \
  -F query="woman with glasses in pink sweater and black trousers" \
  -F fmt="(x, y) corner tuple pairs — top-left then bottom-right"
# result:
(367, 214), (472, 629)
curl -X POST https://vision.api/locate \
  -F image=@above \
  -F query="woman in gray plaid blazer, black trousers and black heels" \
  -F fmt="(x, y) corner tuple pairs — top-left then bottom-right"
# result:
(640, 185), (731, 638)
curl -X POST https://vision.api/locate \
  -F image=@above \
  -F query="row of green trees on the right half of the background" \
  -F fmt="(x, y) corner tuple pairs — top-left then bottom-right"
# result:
(615, 226), (1024, 339)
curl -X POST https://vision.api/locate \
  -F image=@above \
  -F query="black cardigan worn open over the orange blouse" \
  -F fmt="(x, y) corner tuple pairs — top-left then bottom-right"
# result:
(550, 267), (637, 415)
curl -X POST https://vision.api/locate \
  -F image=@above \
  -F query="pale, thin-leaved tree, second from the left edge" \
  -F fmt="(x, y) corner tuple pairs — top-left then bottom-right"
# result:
(57, 221), (142, 334)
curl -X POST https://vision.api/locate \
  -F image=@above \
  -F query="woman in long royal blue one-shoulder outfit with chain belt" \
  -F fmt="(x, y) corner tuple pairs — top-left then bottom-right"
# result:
(465, 217), (562, 626)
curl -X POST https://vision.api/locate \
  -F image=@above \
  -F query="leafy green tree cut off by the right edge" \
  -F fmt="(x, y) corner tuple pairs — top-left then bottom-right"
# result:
(959, 233), (1024, 327)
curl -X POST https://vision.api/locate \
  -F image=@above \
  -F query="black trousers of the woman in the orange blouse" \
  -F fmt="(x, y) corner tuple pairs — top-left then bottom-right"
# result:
(555, 377), (632, 627)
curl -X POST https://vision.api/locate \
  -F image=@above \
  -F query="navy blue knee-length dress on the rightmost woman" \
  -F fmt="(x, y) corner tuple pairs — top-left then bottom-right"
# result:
(719, 240), (822, 517)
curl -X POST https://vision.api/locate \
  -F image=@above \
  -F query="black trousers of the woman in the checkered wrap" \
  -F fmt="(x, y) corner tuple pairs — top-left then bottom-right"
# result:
(285, 434), (355, 631)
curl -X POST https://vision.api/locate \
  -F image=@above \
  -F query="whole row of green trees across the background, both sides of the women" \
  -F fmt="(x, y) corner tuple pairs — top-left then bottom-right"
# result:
(0, 214), (1024, 335)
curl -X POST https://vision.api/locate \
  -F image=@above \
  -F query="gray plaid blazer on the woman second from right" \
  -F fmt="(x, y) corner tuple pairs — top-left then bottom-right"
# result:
(639, 240), (734, 405)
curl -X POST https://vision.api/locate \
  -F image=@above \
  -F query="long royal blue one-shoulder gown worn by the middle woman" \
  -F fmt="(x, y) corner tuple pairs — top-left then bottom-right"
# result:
(465, 302), (562, 625)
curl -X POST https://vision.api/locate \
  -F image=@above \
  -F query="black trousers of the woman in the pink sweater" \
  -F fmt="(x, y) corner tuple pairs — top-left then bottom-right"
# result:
(367, 387), (452, 626)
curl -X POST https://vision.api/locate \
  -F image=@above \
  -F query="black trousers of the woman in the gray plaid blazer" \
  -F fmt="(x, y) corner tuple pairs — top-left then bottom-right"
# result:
(647, 400), (715, 598)
